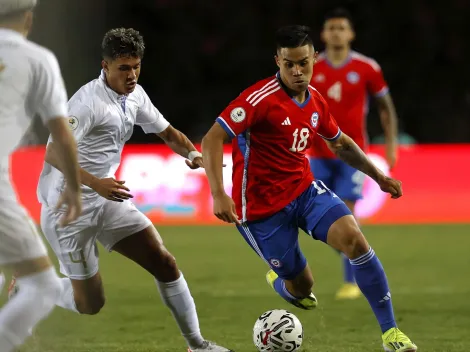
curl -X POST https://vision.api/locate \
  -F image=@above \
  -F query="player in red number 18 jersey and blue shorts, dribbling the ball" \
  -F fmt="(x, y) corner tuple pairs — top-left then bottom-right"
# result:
(202, 26), (416, 352)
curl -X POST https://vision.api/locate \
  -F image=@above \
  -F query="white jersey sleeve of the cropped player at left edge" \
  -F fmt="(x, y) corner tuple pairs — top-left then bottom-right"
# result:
(31, 51), (67, 123)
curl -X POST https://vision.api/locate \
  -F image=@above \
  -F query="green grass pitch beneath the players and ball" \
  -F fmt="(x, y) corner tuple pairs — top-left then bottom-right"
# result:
(12, 225), (470, 352)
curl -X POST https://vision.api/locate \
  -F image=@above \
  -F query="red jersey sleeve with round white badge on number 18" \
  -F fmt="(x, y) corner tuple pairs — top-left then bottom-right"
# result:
(216, 93), (260, 138)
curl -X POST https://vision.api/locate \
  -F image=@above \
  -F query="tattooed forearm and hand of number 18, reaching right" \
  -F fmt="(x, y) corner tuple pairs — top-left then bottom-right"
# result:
(325, 133), (403, 198)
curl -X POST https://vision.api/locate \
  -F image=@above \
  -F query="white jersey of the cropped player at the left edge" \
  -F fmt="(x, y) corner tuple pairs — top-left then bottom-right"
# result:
(0, 28), (67, 166)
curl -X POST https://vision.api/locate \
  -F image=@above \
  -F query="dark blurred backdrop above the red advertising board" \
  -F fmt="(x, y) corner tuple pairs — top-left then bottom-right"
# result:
(28, 0), (470, 143)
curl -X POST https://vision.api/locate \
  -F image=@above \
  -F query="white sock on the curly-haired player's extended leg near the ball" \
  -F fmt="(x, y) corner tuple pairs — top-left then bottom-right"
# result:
(155, 273), (204, 349)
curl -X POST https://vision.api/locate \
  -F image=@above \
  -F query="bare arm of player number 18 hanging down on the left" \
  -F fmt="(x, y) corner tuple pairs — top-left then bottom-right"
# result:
(202, 123), (240, 224)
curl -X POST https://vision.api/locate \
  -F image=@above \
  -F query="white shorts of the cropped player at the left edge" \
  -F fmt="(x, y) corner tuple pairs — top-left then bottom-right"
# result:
(0, 199), (47, 266)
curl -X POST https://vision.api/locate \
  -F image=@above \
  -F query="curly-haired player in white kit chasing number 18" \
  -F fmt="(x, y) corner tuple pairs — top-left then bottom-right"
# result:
(33, 28), (229, 352)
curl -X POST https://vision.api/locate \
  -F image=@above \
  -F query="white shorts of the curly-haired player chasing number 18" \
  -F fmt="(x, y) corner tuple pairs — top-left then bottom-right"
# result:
(41, 200), (152, 280)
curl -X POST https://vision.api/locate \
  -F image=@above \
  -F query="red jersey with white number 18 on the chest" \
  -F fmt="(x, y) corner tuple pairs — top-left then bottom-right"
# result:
(217, 76), (341, 221)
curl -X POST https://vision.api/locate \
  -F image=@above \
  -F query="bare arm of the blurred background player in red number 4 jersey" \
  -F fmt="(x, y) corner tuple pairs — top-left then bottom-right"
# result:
(377, 93), (398, 169)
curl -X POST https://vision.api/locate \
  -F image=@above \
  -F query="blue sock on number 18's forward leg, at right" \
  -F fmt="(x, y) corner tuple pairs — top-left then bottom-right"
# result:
(350, 248), (397, 333)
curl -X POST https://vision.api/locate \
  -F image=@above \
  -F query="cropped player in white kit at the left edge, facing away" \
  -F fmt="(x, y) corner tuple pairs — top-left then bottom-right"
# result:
(0, 0), (81, 352)
